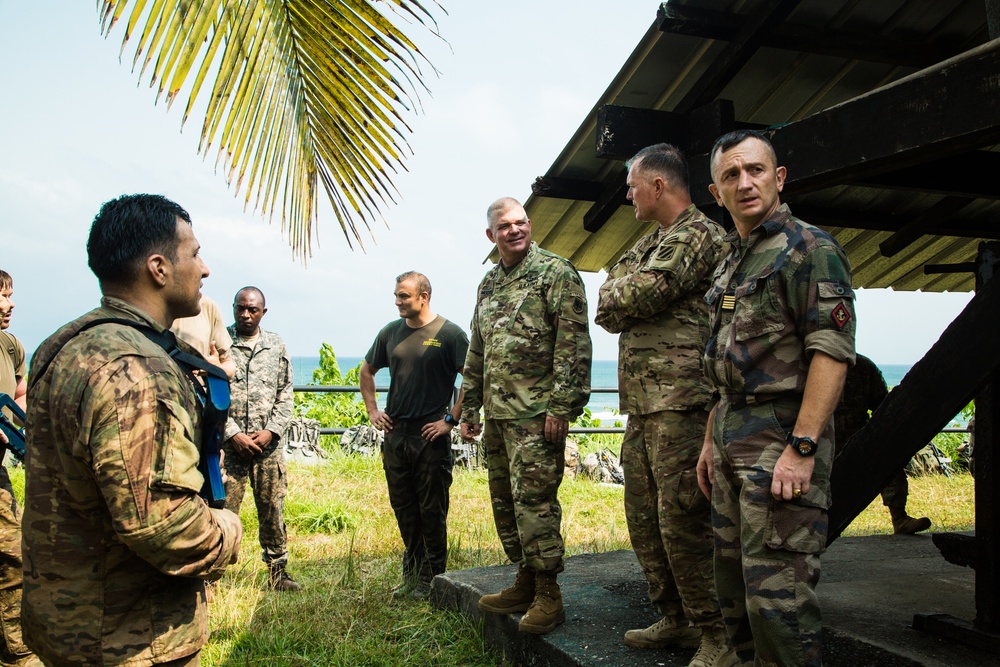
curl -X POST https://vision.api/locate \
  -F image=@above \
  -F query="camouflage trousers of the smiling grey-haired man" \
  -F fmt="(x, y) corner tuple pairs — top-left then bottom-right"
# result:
(483, 414), (566, 573)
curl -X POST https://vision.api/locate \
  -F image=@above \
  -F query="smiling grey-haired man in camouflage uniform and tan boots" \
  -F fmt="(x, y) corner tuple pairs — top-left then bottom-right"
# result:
(461, 197), (591, 634)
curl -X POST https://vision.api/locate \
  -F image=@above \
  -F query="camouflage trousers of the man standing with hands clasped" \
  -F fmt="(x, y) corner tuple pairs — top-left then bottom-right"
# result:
(222, 438), (288, 564)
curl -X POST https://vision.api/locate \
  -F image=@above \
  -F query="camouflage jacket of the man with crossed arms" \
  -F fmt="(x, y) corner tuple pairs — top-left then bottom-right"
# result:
(594, 205), (725, 415)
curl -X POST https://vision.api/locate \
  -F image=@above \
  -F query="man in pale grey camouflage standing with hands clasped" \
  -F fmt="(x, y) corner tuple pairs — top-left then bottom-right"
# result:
(222, 287), (302, 591)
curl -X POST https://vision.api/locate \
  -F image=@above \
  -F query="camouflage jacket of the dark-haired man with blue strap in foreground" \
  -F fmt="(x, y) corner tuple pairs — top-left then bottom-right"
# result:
(22, 297), (243, 665)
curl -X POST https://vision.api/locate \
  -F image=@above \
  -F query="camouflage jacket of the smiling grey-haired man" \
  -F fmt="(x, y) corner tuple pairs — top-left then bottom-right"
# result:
(462, 243), (591, 423)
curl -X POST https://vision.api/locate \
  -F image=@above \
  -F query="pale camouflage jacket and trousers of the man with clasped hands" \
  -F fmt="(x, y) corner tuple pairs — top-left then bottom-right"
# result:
(222, 324), (294, 565)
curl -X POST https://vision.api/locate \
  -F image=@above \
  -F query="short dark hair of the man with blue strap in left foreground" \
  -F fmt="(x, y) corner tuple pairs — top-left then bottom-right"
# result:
(87, 194), (191, 285)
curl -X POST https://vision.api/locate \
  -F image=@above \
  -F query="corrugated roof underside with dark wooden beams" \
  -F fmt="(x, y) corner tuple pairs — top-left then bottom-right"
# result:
(520, 0), (1000, 292)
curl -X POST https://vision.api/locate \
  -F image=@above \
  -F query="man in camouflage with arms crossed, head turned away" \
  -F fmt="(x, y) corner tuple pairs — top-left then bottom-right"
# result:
(594, 144), (735, 667)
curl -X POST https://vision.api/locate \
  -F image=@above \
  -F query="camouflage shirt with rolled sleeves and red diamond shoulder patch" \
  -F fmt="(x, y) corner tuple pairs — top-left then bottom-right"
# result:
(705, 205), (855, 395)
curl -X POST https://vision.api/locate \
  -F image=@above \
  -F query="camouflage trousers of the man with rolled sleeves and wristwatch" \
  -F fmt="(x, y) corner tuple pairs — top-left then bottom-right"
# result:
(712, 397), (833, 667)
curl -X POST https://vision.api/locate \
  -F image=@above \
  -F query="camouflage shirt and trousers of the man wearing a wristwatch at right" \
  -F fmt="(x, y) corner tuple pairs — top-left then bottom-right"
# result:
(705, 205), (855, 667)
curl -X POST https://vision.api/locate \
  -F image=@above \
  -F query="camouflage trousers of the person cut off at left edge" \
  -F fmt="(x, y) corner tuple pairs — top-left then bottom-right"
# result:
(0, 463), (32, 666)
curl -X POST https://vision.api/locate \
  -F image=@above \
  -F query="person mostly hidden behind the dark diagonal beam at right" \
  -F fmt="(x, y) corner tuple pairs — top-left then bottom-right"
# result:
(833, 354), (931, 535)
